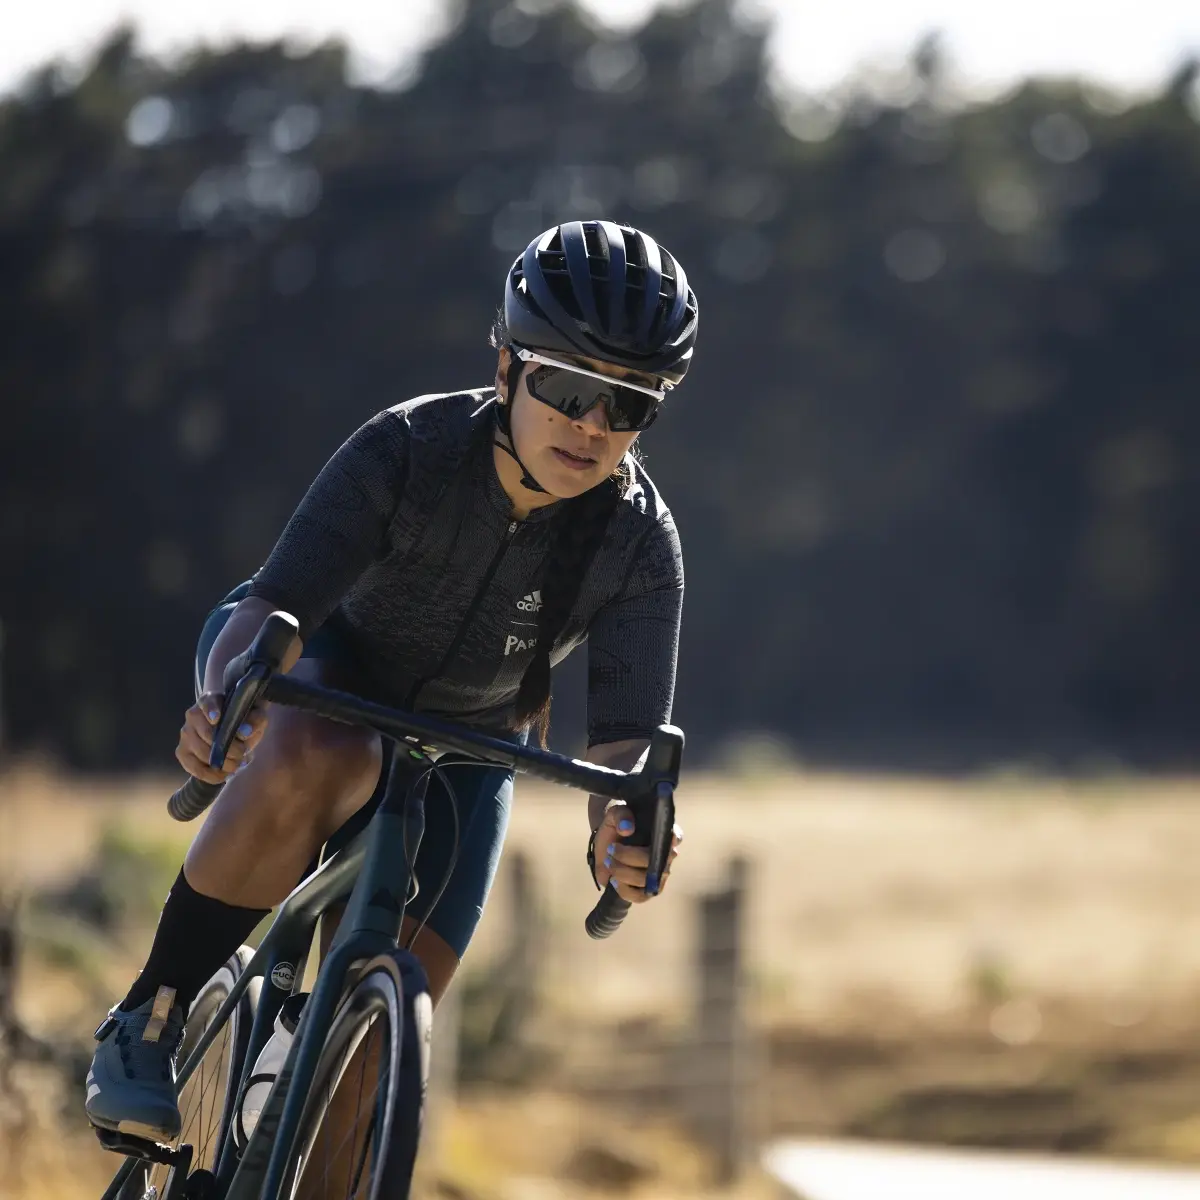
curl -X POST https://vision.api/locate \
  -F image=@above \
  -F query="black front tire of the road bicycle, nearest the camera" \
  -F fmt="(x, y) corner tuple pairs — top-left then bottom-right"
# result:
(280, 949), (433, 1200)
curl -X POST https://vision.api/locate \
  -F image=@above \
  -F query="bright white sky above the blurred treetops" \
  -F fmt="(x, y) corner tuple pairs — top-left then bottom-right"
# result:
(7, 0), (1200, 100)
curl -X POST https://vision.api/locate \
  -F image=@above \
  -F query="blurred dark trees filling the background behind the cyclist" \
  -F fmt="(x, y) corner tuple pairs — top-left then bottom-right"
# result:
(0, 0), (1200, 769)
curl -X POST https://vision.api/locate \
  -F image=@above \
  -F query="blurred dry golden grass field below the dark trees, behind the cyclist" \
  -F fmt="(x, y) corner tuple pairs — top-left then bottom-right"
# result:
(0, 768), (1200, 1200)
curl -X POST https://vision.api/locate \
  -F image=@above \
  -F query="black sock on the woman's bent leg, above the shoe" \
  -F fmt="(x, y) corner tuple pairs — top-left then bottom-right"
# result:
(120, 869), (271, 1013)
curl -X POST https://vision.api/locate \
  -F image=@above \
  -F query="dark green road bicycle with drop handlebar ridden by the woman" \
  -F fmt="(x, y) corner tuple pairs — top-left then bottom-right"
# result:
(97, 612), (684, 1200)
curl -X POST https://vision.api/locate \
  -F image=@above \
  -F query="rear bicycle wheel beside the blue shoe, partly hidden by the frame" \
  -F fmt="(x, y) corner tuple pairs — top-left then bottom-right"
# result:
(120, 946), (260, 1200)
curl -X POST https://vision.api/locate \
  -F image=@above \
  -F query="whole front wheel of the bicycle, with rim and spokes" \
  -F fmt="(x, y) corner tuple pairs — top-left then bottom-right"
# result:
(282, 961), (420, 1200)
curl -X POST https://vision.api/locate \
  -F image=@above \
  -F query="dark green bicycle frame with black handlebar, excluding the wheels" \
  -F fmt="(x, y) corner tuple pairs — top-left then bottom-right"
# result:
(103, 667), (683, 1200)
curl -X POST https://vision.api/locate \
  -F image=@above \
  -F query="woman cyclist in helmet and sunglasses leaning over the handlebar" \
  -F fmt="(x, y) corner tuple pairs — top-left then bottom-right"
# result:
(86, 221), (697, 1142)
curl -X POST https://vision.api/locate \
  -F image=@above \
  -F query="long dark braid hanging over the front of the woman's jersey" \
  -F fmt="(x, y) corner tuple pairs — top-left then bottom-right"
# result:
(516, 469), (624, 750)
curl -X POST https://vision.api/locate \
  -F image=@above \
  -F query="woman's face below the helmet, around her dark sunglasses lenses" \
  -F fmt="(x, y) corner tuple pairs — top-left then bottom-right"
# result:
(497, 347), (658, 500)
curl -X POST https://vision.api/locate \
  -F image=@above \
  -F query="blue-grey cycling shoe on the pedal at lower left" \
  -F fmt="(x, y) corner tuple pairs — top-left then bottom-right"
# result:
(85, 988), (186, 1145)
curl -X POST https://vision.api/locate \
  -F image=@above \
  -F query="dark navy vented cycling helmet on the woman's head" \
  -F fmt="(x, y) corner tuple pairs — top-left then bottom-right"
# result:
(504, 221), (698, 388)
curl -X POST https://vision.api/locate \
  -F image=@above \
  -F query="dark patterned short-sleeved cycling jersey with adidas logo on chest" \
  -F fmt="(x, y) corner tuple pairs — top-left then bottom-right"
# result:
(250, 390), (683, 745)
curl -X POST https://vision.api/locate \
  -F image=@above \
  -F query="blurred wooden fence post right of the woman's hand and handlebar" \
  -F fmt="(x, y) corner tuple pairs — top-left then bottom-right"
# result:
(686, 858), (751, 1186)
